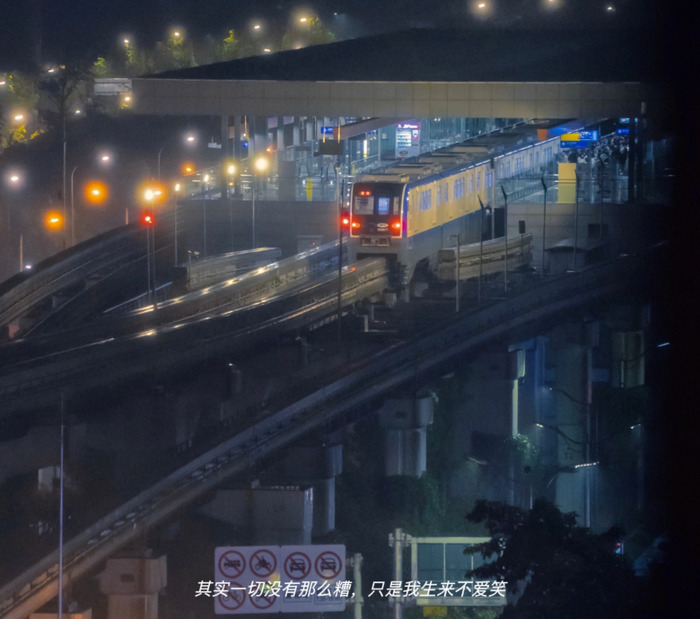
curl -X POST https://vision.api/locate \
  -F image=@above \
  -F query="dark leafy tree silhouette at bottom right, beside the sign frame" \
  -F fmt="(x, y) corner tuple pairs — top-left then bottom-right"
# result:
(465, 499), (637, 619)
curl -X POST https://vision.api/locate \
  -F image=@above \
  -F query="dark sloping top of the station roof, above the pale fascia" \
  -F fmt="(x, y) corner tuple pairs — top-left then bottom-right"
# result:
(148, 28), (665, 82)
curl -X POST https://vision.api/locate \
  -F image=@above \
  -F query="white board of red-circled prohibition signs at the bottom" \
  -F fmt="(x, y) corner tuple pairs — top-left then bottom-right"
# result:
(214, 544), (348, 615)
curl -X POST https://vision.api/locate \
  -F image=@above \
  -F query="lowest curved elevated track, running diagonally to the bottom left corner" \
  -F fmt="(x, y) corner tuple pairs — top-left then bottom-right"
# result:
(0, 248), (665, 619)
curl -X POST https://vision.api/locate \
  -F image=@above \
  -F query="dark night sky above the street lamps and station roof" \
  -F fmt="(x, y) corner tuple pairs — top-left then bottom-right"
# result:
(0, 0), (682, 70)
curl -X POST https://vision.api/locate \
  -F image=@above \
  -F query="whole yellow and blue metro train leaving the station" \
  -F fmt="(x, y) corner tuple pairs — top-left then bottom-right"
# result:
(342, 119), (584, 292)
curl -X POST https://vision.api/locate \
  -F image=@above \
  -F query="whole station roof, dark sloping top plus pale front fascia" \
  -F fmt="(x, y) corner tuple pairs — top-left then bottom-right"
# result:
(133, 28), (672, 124)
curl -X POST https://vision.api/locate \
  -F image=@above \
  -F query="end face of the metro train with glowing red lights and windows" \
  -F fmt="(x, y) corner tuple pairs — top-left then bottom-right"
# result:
(346, 179), (406, 282)
